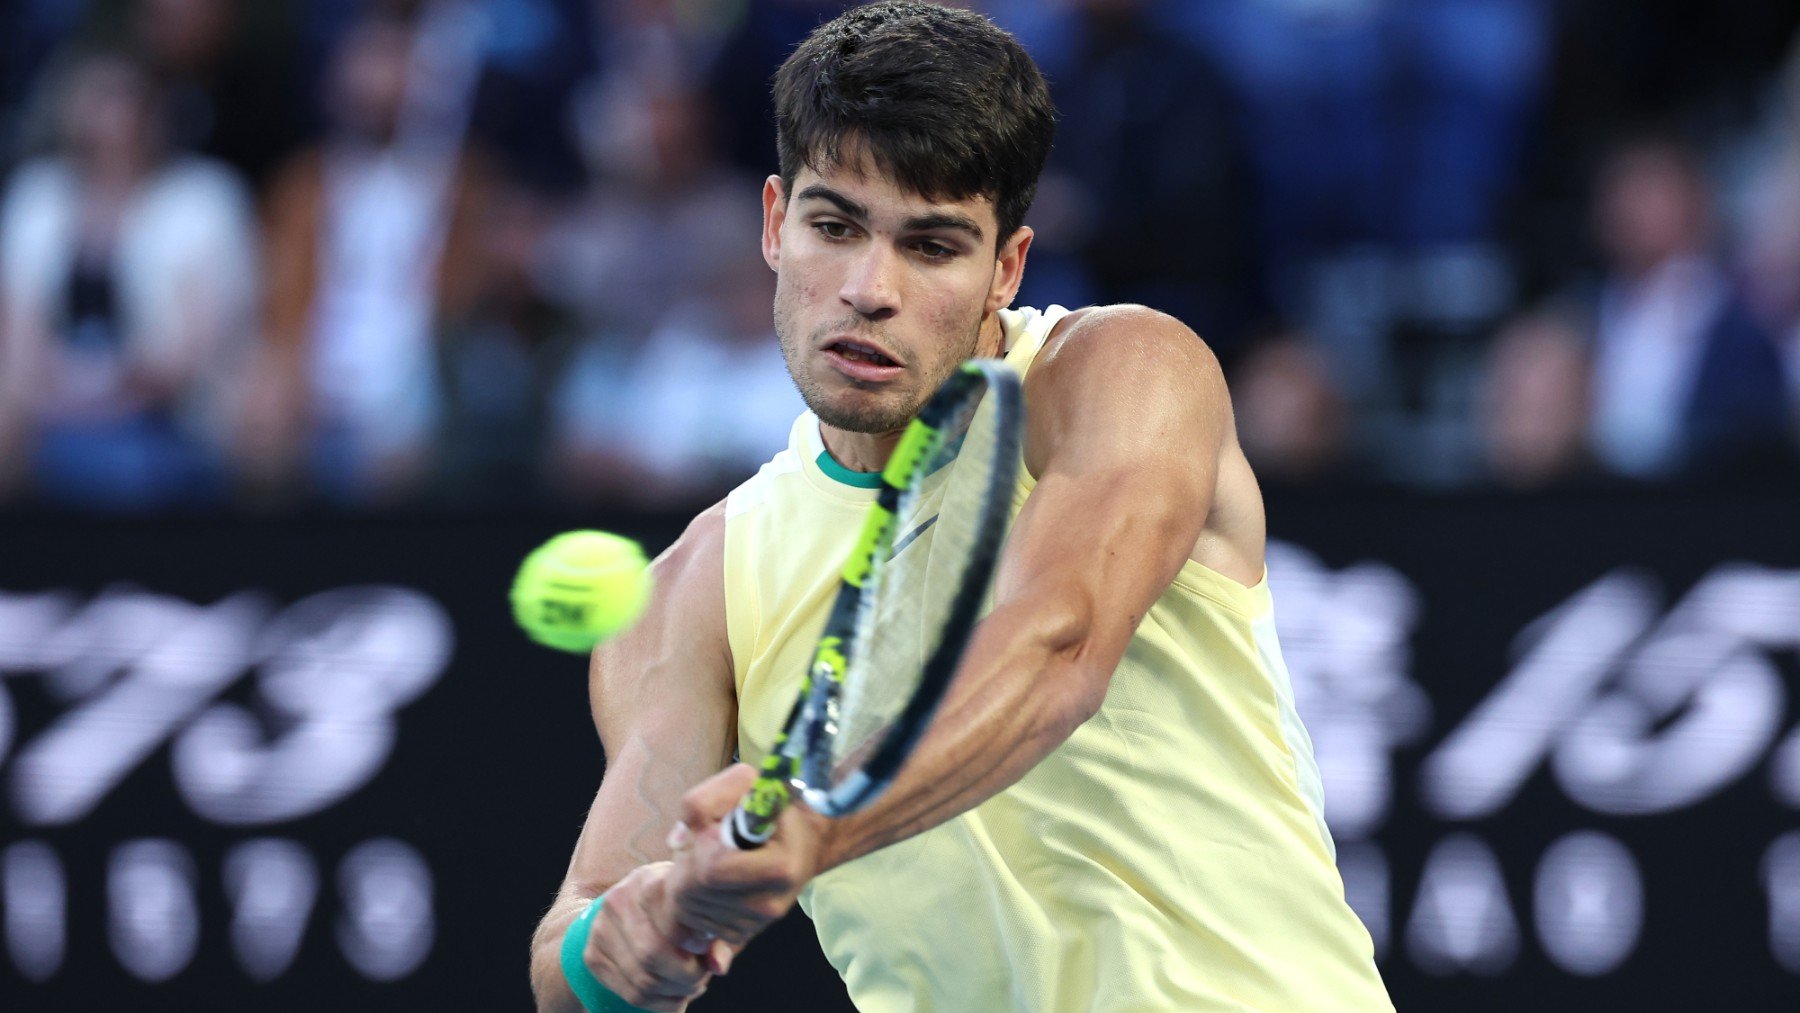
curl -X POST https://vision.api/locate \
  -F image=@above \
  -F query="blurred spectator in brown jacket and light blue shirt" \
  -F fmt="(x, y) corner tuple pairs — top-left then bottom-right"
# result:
(245, 11), (488, 504)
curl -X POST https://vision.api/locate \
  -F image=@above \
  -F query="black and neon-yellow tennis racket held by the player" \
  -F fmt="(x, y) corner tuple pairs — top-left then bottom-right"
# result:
(720, 358), (1024, 849)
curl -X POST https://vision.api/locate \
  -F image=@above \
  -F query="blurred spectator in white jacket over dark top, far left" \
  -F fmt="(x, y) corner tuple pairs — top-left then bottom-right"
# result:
(0, 52), (257, 509)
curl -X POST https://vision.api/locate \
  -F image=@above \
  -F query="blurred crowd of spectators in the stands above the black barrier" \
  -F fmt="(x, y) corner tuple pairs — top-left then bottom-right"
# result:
(0, 0), (1800, 511)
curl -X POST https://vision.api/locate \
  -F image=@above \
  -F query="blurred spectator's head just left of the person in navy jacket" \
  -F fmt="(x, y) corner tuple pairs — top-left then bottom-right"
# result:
(1478, 309), (1593, 489)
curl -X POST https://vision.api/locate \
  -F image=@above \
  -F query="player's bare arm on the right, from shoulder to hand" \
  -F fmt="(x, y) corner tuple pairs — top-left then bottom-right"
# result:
(677, 306), (1231, 943)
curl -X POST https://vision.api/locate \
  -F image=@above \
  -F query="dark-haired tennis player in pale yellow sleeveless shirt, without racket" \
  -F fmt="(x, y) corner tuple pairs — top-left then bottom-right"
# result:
(533, 2), (1391, 1013)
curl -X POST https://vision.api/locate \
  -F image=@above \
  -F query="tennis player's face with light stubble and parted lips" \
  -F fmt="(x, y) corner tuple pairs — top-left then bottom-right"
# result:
(763, 160), (1031, 434)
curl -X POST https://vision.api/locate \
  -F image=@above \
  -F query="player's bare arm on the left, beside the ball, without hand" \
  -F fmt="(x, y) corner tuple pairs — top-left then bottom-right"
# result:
(531, 506), (736, 1013)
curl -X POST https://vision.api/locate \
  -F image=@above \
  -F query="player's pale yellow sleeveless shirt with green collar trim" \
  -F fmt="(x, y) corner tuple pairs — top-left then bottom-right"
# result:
(725, 308), (1393, 1013)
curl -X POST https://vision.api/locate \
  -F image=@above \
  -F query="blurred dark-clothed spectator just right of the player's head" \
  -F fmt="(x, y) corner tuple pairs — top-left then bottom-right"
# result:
(1019, 0), (1258, 356)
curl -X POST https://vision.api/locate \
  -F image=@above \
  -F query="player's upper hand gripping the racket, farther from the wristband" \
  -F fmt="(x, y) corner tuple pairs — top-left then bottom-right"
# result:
(670, 763), (830, 954)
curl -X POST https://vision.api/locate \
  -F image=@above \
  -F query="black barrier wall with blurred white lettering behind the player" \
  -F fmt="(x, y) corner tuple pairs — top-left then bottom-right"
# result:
(0, 493), (1800, 1011)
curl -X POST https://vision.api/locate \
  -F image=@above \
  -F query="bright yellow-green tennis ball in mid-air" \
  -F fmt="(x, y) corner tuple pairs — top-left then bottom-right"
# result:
(513, 531), (650, 653)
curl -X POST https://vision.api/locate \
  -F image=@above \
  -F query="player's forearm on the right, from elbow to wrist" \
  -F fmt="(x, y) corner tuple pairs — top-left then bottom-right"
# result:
(821, 603), (1109, 871)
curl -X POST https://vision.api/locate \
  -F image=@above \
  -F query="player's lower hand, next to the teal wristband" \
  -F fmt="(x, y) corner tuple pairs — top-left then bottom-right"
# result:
(581, 862), (731, 1013)
